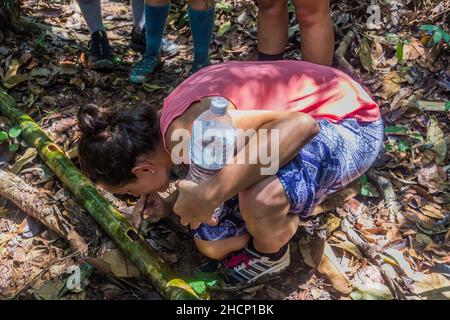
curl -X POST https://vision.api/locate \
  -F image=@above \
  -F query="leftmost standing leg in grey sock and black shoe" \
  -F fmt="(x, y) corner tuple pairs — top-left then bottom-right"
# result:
(78, 0), (113, 69)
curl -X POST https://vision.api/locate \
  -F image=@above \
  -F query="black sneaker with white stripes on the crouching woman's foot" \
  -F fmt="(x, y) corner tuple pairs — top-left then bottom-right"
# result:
(196, 244), (290, 291)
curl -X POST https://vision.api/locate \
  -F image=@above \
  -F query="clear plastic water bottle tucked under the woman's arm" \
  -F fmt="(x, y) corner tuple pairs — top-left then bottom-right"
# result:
(186, 97), (236, 219)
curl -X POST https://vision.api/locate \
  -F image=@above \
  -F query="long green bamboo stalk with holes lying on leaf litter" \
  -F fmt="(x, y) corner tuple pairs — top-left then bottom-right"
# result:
(0, 89), (199, 300)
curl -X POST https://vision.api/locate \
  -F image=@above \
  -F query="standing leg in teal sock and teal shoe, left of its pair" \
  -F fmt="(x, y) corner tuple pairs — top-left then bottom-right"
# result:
(130, 0), (170, 83)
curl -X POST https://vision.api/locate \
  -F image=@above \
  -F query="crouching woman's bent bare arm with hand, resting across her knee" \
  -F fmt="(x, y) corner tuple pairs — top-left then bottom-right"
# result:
(174, 111), (319, 227)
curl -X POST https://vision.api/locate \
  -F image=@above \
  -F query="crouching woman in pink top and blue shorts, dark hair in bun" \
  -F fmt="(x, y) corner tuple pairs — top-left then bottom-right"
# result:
(79, 61), (383, 289)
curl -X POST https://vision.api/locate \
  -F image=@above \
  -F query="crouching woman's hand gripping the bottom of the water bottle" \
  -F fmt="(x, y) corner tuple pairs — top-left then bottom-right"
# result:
(173, 180), (220, 229)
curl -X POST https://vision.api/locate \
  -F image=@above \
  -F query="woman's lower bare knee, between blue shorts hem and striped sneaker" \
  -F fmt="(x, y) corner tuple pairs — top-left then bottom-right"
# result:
(194, 234), (250, 260)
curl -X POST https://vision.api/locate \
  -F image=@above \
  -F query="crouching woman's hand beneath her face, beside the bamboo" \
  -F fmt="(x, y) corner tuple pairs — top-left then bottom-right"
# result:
(133, 192), (170, 228)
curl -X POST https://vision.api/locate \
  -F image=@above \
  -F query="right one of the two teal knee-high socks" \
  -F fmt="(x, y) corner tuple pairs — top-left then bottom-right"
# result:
(188, 4), (216, 64)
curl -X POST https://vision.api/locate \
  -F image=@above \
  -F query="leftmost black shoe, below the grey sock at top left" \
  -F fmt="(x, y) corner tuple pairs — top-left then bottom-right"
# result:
(88, 30), (114, 70)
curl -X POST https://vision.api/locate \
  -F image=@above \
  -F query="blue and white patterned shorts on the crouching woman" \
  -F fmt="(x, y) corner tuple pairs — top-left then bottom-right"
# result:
(191, 118), (384, 241)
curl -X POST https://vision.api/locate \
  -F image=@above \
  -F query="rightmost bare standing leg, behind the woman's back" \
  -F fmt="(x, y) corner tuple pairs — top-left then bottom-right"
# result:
(294, 0), (334, 66)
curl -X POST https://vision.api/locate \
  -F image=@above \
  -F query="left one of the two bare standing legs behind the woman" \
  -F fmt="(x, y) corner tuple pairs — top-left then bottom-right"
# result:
(258, 0), (289, 61)
